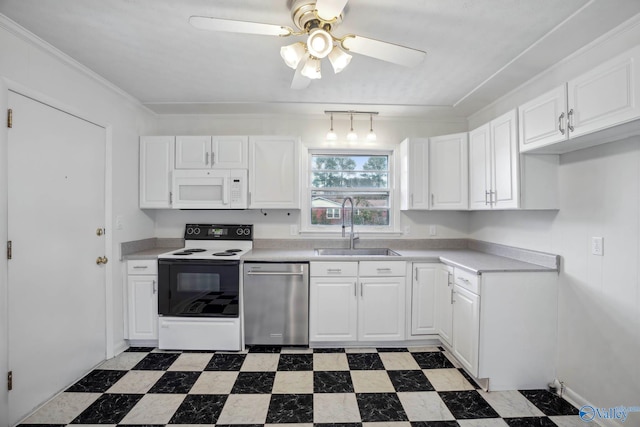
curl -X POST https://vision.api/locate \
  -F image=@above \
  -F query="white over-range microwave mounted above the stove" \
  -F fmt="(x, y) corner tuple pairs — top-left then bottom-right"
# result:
(172, 169), (249, 209)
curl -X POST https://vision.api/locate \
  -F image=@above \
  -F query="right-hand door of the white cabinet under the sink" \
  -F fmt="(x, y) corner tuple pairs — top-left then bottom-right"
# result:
(358, 277), (405, 341)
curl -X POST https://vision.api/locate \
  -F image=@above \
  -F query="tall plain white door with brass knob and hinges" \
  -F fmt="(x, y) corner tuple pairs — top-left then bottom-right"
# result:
(8, 92), (106, 425)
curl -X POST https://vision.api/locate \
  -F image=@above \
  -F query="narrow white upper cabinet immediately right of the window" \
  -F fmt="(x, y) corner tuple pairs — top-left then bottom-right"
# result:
(400, 138), (429, 210)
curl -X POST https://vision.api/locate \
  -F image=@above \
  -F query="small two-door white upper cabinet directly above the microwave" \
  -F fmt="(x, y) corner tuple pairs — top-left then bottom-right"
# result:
(176, 136), (248, 169)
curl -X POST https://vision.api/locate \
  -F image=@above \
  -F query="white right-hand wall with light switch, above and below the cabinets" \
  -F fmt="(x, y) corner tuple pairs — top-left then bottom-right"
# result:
(469, 17), (640, 425)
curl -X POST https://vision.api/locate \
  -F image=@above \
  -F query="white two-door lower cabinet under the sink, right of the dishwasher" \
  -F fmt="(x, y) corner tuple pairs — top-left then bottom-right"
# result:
(309, 261), (406, 342)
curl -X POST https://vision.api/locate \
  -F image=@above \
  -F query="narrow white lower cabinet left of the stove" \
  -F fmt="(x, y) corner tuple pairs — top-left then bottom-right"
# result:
(127, 260), (158, 340)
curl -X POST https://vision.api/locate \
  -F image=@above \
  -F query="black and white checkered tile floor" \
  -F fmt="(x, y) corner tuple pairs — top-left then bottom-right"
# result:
(22, 347), (584, 427)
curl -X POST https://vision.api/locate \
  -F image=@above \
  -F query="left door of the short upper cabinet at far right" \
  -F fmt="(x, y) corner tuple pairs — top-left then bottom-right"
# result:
(518, 84), (569, 153)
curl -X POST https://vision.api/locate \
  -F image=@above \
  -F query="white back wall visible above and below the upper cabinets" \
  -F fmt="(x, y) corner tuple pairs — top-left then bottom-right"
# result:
(147, 115), (469, 239)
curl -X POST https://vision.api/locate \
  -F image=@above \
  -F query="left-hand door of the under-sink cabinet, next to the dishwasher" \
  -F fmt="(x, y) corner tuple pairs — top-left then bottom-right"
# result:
(309, 277), (358, 342)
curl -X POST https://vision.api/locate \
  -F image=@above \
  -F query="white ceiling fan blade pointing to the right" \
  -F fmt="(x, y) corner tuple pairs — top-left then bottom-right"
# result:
(342, 35), (427, 67)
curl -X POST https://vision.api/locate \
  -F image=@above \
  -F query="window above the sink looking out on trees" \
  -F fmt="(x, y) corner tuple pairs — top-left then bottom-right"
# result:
(308, 152), (392, 230)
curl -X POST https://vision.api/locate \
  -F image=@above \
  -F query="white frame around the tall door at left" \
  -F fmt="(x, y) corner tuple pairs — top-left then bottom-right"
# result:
(0, 75), (115, 427)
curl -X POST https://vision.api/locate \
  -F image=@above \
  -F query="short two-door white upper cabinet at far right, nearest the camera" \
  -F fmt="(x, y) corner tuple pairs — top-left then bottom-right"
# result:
(519, 46), (640, 153)
